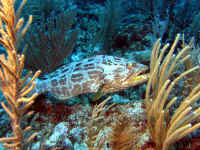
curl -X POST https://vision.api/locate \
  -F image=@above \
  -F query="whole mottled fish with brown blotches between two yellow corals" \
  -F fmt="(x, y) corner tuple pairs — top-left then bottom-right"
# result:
(35, 55), (148, 100)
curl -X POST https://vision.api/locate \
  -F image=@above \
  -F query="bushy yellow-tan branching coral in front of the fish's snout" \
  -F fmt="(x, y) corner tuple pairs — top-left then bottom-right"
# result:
(146, 35), (200, 150)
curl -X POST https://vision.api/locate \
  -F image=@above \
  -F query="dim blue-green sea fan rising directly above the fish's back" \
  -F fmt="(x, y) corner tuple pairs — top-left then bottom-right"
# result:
(94, 0), (124, 54)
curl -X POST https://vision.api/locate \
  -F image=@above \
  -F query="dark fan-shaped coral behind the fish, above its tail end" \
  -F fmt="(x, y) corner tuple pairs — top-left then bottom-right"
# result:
(21, 8), (78, 74)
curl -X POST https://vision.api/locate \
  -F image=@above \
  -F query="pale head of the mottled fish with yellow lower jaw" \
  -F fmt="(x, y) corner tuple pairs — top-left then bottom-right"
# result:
(103, 59), (148, 93)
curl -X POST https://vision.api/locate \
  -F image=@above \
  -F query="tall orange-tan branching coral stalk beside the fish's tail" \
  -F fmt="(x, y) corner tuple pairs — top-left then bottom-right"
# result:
(0, 0), (40, 150)
